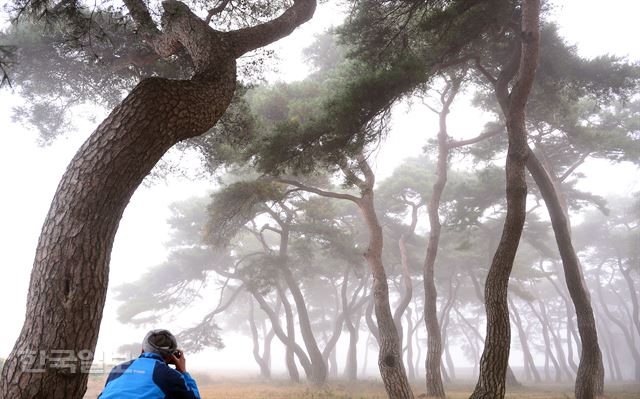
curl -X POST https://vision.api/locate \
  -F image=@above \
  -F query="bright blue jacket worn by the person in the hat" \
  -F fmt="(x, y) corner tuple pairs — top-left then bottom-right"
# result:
(98, 353), (200, 399)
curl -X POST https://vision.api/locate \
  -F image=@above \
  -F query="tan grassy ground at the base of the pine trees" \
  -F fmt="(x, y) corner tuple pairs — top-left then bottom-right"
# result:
(85, 374), (640, 399)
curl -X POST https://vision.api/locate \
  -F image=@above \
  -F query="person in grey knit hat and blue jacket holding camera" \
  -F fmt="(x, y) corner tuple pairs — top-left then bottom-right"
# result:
(98, 330), (200, 399)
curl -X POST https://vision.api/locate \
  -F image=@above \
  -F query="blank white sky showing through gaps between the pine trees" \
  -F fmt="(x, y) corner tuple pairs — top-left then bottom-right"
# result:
(0, 0), (640, 378)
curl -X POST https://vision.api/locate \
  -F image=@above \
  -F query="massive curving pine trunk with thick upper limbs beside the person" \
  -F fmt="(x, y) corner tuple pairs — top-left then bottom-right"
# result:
(0, 0), (315, 399)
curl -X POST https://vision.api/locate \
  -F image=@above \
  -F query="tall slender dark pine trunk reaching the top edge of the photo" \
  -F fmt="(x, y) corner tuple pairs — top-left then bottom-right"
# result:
(471, 0), (540, 399)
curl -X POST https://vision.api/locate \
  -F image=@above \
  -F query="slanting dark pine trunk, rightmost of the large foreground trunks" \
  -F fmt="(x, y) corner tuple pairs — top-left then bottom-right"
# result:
(527, 150), (604, 399)
